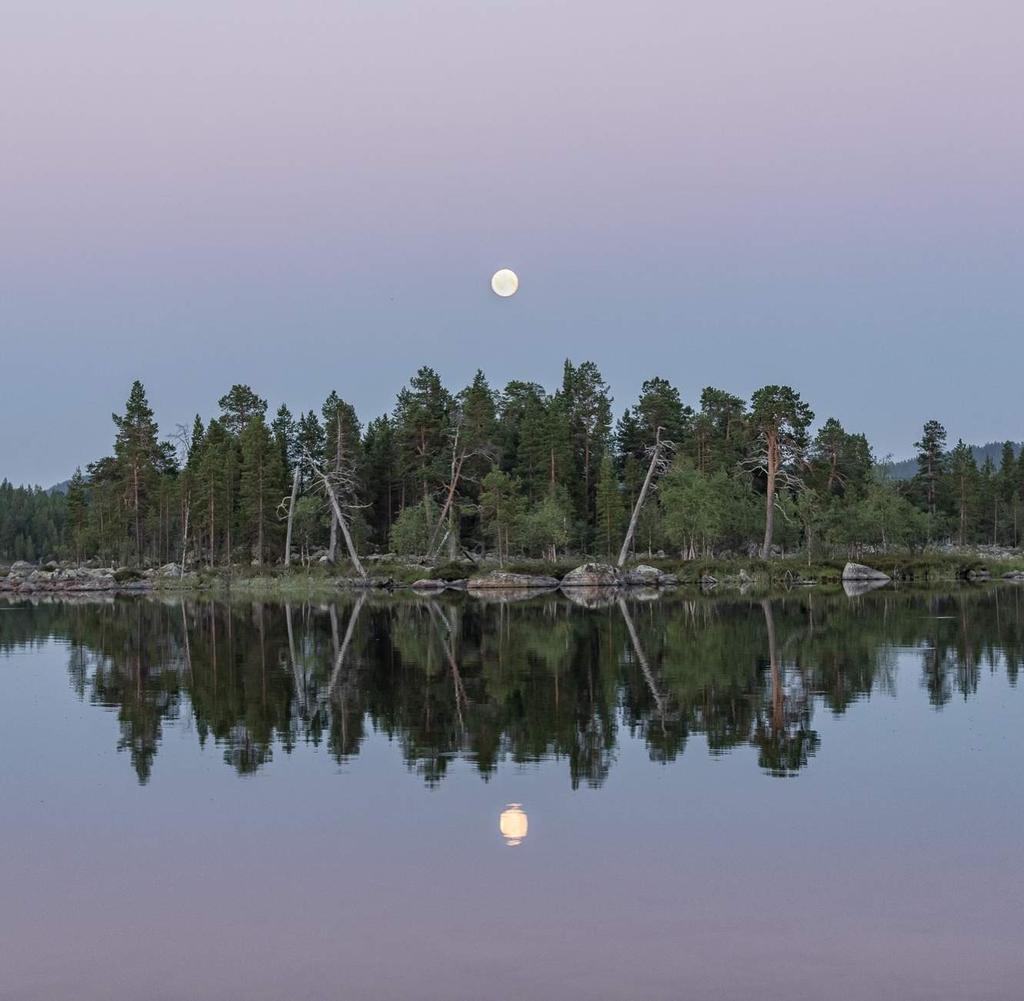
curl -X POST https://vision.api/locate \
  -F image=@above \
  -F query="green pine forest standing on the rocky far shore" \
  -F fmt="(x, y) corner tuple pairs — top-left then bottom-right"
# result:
(0, 361), (1024, 565)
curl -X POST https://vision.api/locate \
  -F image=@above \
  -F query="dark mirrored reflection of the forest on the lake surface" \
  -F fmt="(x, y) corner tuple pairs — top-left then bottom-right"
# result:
(0, 586), (1024, 787)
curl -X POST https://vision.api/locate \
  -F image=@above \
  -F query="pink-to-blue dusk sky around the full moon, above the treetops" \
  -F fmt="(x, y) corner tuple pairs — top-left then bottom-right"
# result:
(0, 0), (1024, 484)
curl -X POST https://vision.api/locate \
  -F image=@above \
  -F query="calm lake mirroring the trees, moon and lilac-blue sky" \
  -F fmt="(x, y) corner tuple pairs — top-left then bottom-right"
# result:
(0, 585), (1024, 1001)
